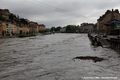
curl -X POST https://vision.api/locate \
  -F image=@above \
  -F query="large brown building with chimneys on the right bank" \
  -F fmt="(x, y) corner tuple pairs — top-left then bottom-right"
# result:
(97, 9), (120, 34)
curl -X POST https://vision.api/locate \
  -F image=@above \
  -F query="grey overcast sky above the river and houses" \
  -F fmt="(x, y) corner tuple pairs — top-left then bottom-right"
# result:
(0, 0), (120, 27)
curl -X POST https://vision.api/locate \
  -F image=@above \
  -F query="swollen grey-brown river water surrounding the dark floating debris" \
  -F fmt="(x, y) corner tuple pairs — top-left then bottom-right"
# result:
(0, 34), (120, 80)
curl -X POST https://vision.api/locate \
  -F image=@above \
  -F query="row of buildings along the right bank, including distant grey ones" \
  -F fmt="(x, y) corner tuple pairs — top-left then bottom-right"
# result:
(80, 9), (120, 35)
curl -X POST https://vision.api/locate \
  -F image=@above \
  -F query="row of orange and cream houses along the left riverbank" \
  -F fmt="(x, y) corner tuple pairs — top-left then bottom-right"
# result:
(0, 9), (45, 37)
